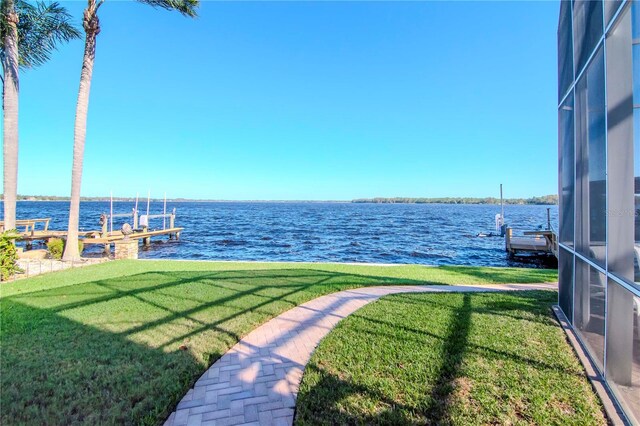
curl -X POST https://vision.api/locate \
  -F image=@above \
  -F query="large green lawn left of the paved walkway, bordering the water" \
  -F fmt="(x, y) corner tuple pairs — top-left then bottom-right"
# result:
(0, 261), (557, 424)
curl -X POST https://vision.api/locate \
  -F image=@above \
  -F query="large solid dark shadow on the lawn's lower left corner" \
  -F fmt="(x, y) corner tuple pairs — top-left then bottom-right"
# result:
(0, 300), (202, 424)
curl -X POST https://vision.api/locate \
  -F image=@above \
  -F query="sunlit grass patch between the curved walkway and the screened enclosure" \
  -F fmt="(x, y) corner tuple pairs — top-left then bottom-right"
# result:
(296, 291), (606, 425)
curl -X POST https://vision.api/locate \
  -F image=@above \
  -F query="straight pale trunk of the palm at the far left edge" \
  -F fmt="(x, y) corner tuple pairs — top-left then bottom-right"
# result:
(2, 0), (19, 230)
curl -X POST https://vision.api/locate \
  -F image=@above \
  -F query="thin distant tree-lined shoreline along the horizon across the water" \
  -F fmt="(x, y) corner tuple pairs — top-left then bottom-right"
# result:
(0, 195), (558, 205)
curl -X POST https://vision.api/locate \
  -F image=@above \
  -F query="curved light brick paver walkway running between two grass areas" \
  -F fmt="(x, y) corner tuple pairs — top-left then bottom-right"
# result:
(165, 284), (557, 426)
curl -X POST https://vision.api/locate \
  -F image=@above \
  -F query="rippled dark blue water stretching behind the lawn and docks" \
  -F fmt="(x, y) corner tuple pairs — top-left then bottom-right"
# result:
(7, 202), (558, 266)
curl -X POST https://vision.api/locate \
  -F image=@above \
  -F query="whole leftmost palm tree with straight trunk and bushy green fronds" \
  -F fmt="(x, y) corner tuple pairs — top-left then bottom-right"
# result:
(0, 0), (80, 229)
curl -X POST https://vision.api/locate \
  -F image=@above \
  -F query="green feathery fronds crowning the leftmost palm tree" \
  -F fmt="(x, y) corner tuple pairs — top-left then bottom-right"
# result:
(0, 0), (81, 68)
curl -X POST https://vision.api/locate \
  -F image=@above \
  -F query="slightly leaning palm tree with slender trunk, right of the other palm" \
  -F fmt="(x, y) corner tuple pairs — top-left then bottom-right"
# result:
(62, 0), (199, 260)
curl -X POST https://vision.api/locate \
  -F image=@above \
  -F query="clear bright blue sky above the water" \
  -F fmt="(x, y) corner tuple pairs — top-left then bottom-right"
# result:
(2, 1), (558, 200)
